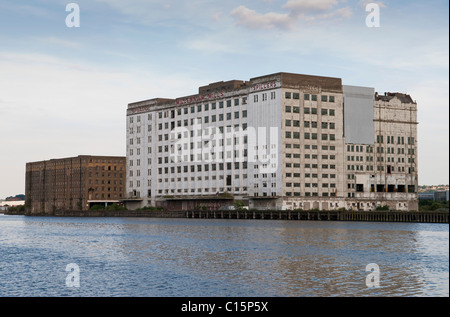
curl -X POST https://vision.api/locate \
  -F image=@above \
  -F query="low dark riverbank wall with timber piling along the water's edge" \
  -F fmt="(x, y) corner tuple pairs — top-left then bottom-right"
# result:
(5, 210), (449, 223)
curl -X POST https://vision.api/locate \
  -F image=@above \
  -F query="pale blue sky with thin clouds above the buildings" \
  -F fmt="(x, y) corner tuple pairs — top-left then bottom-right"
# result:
(0, 0), (449, 199)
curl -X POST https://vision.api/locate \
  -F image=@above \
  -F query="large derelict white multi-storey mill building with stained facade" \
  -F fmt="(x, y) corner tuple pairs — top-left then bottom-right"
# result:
(126, 73), (418, 210)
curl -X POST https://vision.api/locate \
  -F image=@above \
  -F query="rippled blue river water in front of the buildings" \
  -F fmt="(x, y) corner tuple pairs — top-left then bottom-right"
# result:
(0, 215), (449, 297)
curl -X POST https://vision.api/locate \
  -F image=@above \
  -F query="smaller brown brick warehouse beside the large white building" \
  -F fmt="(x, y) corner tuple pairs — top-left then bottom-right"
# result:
(25, 155), (126, 214)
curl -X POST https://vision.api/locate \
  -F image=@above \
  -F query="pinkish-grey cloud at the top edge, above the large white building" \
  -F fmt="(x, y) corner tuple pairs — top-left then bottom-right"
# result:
(231, 0), (352, 30)
